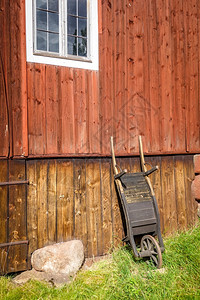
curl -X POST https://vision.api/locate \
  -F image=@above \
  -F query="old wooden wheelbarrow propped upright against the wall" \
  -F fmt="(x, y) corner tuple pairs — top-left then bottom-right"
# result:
(111, 136), (164, 268)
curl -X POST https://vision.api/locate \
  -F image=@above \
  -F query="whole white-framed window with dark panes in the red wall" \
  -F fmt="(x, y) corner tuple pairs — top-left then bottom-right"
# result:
(26, 0), (98, 70)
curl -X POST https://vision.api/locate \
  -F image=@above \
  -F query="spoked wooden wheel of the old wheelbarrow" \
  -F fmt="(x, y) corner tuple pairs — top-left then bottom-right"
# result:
(141, 235), (162, 269)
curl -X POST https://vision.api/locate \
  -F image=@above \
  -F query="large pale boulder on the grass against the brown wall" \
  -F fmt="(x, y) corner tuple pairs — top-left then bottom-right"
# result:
(31, 240), (84, 276)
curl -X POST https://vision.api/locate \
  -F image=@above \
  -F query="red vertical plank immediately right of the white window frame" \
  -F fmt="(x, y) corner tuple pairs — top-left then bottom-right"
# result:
(99, 0), (114, 154)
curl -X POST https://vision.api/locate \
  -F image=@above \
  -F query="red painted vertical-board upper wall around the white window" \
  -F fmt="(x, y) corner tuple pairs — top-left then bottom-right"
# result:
(0, 0), (200, 157)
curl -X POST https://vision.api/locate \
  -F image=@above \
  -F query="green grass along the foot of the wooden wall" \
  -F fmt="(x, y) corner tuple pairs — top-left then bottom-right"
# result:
(0, 224), (200, 300)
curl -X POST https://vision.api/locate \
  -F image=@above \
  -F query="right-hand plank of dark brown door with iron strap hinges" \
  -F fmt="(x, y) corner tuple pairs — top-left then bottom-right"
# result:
(8, 160), (27, 272)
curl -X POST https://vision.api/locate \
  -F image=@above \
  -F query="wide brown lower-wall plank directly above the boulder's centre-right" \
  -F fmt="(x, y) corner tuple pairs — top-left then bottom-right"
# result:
(57, 160), (74, 242)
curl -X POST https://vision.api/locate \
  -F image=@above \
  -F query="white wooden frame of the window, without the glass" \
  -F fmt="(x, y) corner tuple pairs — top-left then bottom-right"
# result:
(26, 0), (99, 70)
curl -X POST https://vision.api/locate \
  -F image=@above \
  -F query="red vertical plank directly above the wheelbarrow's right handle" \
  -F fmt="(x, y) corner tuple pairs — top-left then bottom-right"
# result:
(128, 1), (146, 153)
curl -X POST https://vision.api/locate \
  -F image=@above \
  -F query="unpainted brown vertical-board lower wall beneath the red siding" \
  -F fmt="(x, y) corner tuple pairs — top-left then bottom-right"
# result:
(0, 155), (197, 273)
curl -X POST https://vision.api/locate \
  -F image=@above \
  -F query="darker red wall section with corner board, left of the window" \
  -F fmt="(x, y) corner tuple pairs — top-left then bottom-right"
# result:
(0, 0), (28, 157)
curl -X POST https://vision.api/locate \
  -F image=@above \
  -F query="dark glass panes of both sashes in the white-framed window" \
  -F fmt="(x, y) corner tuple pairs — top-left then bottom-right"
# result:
(36, 0), (88, 57)
